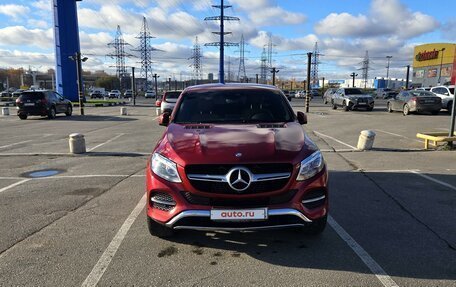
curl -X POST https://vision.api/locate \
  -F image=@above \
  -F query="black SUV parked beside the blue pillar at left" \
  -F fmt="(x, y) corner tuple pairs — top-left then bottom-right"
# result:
(16, 91), (73, 120)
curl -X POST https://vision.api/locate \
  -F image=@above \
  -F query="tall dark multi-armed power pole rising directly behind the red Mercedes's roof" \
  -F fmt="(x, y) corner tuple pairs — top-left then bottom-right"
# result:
(204, 0), (239, 84)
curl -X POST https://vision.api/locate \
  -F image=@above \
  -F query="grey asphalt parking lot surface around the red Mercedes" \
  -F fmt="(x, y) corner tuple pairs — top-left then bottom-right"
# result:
(0, 99), (456, 287)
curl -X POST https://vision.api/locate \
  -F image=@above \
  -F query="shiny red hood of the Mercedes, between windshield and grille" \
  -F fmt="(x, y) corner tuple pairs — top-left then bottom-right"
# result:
(157, 122), (318, 166)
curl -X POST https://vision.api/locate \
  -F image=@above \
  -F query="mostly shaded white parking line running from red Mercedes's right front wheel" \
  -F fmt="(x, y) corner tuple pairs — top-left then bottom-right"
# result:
(328, 215), (399, 287)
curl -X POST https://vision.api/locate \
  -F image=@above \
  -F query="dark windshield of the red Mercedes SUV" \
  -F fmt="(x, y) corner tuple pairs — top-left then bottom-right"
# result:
(174, 90), (294, 124)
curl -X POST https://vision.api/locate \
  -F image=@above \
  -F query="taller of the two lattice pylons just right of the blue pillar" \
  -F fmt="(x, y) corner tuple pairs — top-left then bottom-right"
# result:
(134, 17), (161, 91)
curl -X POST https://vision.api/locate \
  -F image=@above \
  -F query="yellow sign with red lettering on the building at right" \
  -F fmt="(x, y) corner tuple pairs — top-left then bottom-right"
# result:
(413, 43), (456, 68)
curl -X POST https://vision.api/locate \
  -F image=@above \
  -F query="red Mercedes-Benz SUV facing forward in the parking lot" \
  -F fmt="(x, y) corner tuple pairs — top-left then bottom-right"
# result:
(146, 84), (328, 237)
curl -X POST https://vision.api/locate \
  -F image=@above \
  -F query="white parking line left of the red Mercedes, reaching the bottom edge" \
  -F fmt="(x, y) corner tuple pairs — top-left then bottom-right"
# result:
(81, 194), (146, 287)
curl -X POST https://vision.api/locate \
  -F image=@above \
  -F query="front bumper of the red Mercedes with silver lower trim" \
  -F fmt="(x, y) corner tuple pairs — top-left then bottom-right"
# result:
(146, 163), (328, 231)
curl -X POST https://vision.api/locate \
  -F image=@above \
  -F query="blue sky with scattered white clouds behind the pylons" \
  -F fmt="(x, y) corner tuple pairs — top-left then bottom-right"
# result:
(0, 0), (456, 80)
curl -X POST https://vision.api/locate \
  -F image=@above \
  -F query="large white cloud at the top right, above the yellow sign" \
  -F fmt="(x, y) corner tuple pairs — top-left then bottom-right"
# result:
(315, 0), (439, 39)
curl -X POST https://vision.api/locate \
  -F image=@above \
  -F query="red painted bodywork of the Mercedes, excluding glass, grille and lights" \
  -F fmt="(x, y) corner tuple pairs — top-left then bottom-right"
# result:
(146, 84), (328, 236)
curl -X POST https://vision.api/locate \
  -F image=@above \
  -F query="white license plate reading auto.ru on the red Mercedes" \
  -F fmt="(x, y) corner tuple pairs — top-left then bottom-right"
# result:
(211, 208), (268, 221)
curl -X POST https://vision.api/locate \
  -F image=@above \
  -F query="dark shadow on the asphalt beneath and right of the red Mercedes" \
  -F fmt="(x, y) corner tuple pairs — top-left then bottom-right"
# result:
(152, 171), (456, 280)
